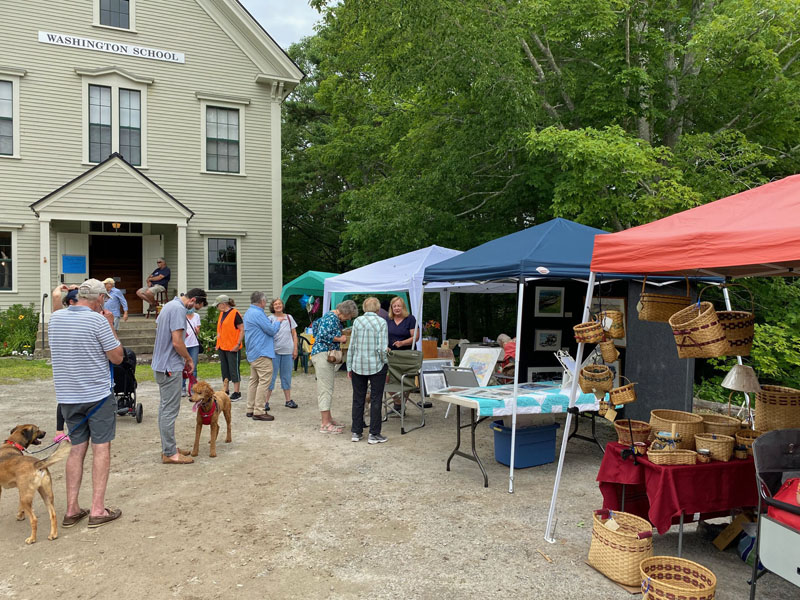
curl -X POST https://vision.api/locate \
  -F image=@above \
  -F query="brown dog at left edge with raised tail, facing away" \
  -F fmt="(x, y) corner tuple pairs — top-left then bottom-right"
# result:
(0, 425), (71, 544)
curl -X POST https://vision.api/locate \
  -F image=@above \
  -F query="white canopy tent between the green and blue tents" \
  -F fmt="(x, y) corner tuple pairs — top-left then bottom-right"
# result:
(322, 245), (517, 347)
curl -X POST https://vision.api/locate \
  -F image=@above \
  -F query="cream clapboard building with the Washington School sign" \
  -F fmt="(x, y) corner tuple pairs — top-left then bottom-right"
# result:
(0, 0), (303, 313)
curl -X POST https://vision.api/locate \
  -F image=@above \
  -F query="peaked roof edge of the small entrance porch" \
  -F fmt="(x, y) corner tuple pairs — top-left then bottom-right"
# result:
(30, 152), (194, 221)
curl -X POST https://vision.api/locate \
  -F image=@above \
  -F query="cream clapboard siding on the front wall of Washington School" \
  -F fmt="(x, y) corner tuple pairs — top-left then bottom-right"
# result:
(0, 0), (296, 308)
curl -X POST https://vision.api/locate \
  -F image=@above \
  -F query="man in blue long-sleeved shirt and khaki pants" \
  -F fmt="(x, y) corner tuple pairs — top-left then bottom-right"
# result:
(244, 292), (281, 421)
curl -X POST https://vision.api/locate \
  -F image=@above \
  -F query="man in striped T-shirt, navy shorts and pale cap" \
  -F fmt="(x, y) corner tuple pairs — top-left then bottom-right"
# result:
(48, 279), (123, 527)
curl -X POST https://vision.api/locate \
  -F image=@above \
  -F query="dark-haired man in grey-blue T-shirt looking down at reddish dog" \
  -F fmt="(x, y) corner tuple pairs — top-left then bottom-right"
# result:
(150, 288), (208, 465)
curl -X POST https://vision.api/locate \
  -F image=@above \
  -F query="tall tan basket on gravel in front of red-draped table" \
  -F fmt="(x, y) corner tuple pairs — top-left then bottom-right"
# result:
(589, 510), (653, 585)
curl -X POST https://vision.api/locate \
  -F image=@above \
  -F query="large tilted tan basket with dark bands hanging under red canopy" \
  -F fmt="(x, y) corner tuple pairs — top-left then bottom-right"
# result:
(669, 302), (730, 358)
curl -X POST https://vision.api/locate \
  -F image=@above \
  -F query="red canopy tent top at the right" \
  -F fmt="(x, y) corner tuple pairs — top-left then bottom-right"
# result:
(591, 175), (800, 277)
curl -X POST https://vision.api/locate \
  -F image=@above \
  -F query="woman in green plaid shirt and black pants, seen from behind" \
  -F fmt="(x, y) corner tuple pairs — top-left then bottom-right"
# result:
(347, 297), (389, 444)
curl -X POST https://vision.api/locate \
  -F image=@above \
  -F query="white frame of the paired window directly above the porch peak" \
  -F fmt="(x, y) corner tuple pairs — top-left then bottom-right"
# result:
(80, 72), (152, 169)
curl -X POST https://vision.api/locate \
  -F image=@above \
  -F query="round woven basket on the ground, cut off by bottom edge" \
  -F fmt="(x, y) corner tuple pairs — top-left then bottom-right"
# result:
(639, 556), (717, 600)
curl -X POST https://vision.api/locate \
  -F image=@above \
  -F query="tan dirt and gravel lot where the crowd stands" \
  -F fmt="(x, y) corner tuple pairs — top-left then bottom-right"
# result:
(0, 366), (797, 600)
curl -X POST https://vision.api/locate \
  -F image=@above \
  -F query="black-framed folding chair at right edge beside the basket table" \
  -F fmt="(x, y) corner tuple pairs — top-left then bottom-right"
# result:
(750, 429), (800, 600)
